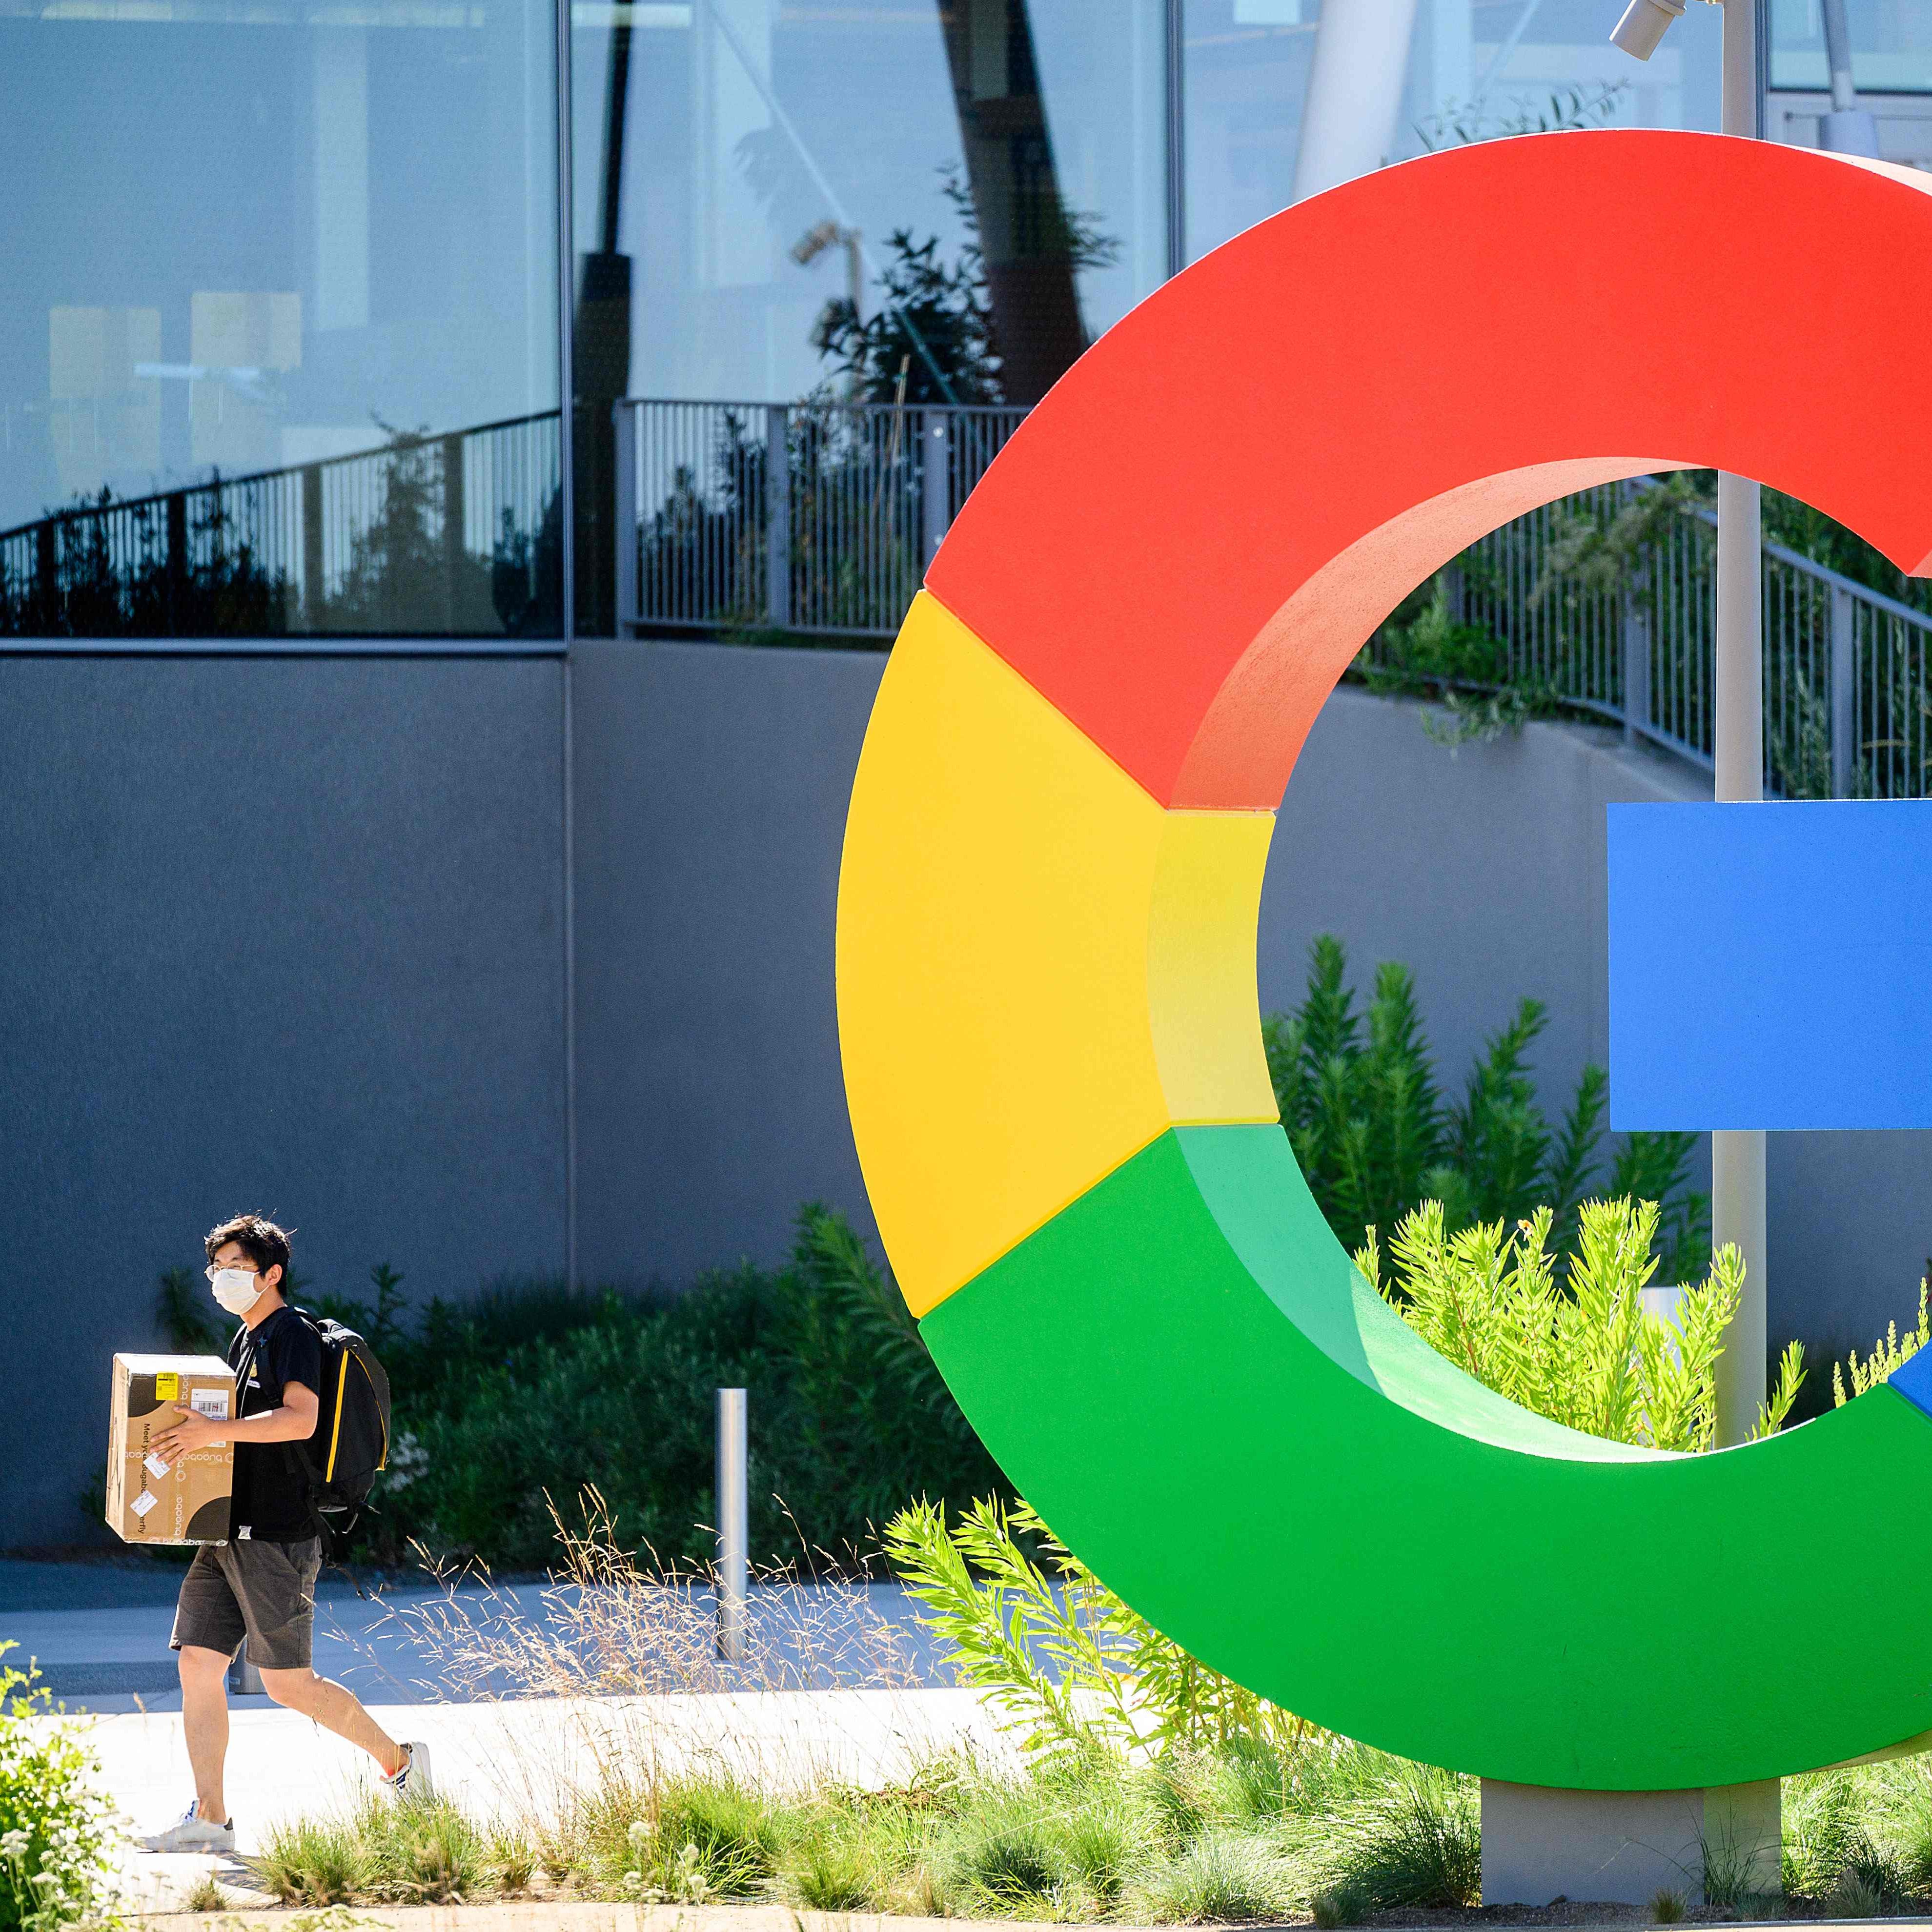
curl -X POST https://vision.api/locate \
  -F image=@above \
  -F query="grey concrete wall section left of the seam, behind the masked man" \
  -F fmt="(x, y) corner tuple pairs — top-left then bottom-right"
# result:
(0, 657), (564, 1547)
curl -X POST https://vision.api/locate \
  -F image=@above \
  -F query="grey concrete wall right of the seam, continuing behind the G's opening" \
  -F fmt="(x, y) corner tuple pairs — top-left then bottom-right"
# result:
(574, 643), (1932, 1375)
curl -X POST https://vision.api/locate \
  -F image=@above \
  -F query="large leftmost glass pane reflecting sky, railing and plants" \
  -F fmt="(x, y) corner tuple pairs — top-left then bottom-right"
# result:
(0, 0), (560, 636)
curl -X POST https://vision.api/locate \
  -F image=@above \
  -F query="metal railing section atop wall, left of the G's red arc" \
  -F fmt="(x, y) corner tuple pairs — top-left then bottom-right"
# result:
(614, 398), (1026, 637)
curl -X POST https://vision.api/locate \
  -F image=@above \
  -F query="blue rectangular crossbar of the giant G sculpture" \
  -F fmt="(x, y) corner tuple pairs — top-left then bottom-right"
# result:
(1609, 800), (1932, 1132)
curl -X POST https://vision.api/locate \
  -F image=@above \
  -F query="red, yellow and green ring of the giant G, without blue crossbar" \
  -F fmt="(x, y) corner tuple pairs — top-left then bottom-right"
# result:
(838, 131), (1932, 1789)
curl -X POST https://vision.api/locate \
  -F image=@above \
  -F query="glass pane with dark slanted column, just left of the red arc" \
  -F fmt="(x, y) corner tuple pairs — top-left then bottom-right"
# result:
(572, 0), (1167, 632)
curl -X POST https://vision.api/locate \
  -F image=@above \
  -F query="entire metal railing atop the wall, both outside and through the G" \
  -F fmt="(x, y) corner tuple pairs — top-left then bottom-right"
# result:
(614, 398), (1932, 798)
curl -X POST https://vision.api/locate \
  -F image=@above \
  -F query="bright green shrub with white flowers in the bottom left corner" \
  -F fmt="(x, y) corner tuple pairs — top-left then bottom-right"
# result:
(0, 1642), (114, 1932)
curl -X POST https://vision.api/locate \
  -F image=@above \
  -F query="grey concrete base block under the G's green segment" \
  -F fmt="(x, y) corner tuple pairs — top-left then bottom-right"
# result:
(1482, 1777), (1781, 1907)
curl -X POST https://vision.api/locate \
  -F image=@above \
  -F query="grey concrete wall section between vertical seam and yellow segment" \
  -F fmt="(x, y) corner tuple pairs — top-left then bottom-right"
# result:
(572, 643), (885, 1283)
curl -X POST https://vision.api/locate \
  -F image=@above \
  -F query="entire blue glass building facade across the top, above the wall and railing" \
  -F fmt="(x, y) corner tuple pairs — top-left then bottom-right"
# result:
(0, 0), (1932, 647)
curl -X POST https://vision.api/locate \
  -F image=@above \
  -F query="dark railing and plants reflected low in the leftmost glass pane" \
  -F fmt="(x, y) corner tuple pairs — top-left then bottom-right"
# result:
(0, 409), (562, 637)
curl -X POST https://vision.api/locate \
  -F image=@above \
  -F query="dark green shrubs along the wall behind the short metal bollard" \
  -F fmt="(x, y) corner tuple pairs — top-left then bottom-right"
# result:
(328, 1207), (1005, 1569)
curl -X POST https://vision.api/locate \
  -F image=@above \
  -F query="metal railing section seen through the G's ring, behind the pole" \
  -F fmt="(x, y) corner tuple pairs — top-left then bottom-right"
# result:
(1358, 483), (1932, 798)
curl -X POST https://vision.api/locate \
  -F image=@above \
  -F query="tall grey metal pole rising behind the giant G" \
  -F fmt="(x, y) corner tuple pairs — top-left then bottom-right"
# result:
(1710, 0), (1766, 1445)
